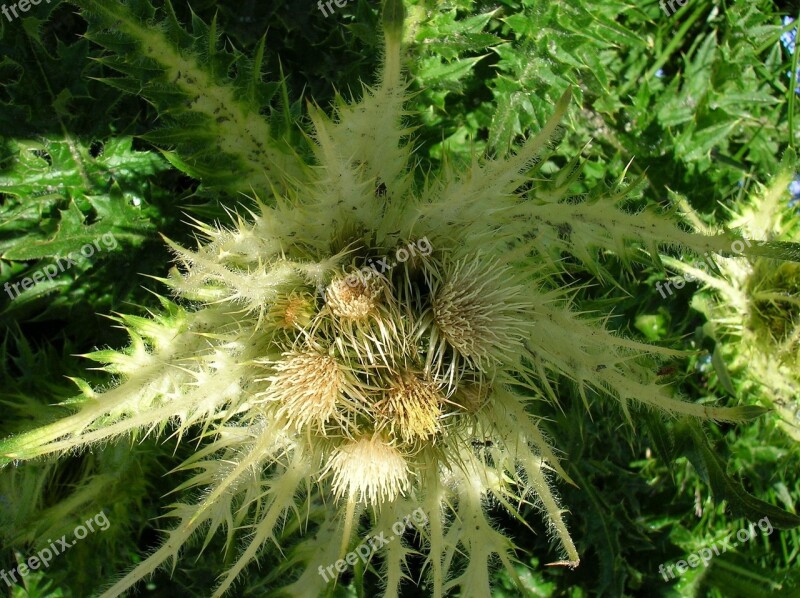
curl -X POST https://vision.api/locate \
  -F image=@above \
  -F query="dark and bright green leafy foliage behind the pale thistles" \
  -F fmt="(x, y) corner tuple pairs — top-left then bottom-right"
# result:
(0, 0), (800, 597)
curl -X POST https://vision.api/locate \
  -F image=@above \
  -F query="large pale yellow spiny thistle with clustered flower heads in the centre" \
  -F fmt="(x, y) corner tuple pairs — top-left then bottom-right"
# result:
(0, 0), (792, 596)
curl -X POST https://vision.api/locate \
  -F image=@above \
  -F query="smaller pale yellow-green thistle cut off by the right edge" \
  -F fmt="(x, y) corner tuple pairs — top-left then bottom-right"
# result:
(667, 151), (800, 441)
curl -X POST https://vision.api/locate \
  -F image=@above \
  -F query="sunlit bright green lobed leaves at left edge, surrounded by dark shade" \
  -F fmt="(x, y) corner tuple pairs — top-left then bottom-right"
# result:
(0, 137), (164, 260)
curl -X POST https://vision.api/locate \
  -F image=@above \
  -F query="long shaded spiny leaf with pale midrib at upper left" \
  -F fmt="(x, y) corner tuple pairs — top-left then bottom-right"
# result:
(69, 0), (302, 197)
